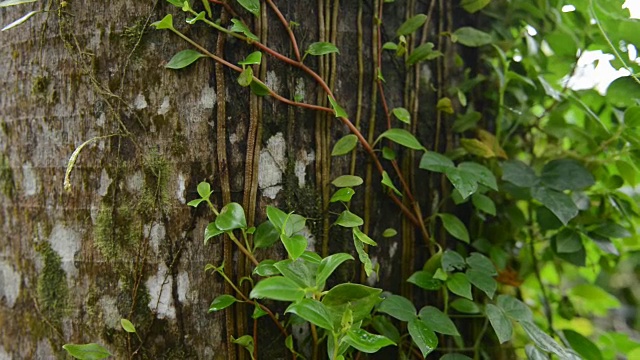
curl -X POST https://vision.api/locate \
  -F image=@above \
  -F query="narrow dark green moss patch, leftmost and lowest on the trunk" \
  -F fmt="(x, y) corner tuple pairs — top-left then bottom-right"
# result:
(36, 241), (69, 326)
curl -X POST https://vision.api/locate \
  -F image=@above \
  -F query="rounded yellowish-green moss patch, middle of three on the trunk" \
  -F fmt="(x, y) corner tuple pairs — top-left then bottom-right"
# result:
(94, 203), (141, 262)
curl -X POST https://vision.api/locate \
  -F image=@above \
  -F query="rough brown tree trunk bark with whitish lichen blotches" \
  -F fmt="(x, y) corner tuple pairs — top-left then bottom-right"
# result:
(0, 0), (460, 359)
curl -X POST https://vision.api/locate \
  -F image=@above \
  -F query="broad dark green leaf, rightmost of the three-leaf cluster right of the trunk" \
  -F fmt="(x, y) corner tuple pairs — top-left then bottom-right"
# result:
(540, 159), (595, 191)
